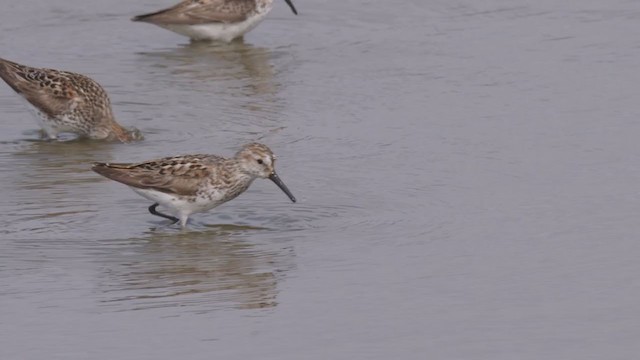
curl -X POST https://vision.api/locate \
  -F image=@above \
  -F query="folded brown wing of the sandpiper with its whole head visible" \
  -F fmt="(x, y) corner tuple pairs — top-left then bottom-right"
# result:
(92, 155), (223, 196)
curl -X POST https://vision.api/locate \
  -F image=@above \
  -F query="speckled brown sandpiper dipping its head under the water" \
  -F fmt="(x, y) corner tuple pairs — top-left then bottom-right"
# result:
(0, 59), (142, 142)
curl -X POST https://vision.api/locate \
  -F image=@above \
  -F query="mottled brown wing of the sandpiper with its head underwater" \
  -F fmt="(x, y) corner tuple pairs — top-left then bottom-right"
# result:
(0, 59), (82, 117)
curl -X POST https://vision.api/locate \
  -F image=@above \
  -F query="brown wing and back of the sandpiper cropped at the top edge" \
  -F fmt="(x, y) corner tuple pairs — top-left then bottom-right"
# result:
(133, 0), (255, 25)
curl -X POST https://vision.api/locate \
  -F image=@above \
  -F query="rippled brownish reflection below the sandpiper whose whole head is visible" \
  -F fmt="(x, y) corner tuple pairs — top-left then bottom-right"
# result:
(96, 225), (295, 312)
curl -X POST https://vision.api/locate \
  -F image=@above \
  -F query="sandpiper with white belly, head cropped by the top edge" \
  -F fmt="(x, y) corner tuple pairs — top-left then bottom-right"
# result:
(131, 0), (298, 42)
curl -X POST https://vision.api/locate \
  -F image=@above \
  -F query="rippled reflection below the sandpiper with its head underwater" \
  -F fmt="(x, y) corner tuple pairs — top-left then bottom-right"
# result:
(0, 140), (122, 237)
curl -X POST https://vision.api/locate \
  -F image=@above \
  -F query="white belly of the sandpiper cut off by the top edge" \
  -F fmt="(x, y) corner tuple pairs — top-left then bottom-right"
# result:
(158, 11), (269, 42)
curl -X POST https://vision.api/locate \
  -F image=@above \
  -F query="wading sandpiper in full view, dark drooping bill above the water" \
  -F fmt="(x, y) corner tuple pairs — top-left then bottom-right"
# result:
(92, 143), (296, 228)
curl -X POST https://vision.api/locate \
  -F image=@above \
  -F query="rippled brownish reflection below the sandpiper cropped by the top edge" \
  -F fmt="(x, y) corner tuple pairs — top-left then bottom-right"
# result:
(139, 42), (286, 126)
